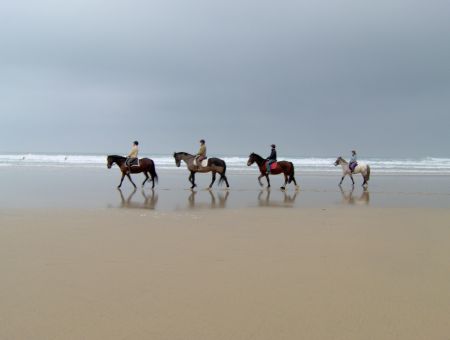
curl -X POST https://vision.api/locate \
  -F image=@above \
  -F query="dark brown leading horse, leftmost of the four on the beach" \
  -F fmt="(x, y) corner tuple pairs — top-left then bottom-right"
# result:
(106, 155), (158, 189)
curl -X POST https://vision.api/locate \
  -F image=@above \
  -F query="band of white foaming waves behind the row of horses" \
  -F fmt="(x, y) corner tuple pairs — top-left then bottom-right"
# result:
(0, 154), (450, 175)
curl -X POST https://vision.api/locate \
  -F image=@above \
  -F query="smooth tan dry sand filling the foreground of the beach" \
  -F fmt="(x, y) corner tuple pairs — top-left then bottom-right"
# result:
(0, 208), (450, 340)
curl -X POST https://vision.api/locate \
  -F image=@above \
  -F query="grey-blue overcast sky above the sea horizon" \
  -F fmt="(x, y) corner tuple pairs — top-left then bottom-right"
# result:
(0, 0), (450, 157)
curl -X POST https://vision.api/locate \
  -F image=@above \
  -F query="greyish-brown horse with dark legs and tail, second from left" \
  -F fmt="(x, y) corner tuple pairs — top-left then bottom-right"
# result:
(173, 152), (230, 189)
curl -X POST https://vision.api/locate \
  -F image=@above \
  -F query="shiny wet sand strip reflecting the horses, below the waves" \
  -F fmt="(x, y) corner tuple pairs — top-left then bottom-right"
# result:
(0, 167), (450, 211)
